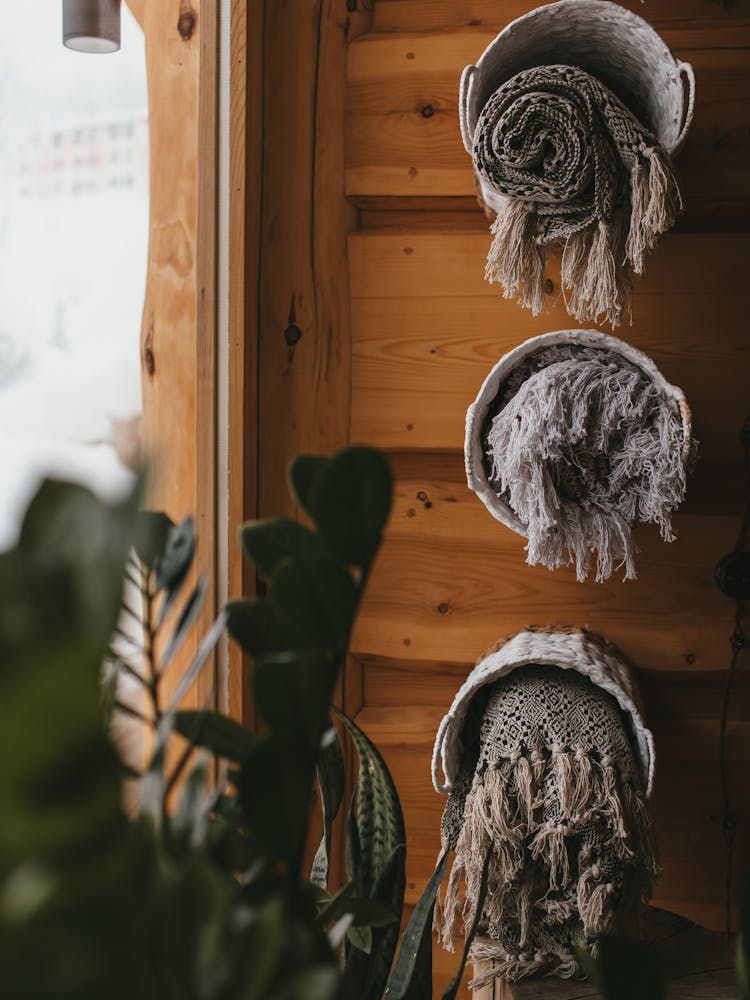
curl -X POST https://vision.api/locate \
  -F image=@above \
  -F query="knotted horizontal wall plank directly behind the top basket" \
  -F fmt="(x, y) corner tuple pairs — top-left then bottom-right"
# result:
(346, 28), (750, 225)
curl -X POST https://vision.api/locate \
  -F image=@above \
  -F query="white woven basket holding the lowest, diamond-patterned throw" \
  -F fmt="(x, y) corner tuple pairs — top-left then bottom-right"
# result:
(432, 629), (655, 797)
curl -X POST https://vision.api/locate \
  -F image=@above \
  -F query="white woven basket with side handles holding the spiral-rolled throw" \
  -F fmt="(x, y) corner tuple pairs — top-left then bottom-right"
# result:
(458, 0), (695, 212)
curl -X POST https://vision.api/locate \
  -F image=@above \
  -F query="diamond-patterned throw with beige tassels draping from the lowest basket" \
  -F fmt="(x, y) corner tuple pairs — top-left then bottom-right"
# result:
(435, 666), (658, 987)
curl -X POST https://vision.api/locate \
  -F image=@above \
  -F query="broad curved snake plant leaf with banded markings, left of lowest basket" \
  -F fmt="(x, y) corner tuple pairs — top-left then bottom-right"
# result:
(334, 709), (406, 896)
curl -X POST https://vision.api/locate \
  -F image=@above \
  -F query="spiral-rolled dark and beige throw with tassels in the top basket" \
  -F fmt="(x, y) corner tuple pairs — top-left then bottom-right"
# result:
(473, 66), (682, 326)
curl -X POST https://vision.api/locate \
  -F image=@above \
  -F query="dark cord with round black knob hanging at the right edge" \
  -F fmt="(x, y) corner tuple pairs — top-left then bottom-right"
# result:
(716, 416), (750, 938)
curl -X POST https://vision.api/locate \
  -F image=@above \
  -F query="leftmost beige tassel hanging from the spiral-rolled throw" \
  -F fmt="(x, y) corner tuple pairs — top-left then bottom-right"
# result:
(484, 199), (546, 316)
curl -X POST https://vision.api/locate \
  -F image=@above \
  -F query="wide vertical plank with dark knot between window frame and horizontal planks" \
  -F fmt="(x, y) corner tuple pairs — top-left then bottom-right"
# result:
(257, 0), (365, 528)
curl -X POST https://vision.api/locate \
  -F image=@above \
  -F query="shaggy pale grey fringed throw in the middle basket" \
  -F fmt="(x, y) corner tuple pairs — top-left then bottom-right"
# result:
(484, 344), (686, 581)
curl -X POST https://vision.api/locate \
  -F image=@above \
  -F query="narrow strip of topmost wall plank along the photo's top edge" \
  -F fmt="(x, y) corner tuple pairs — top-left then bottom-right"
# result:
(373, 0), (750, 47)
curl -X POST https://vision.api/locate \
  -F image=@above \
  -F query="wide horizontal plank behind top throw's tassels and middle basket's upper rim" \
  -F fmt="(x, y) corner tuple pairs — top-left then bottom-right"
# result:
(349, 232), (750, 463)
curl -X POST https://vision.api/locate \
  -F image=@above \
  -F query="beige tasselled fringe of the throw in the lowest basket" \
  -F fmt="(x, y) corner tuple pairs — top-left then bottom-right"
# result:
(433, 745), (658, 988)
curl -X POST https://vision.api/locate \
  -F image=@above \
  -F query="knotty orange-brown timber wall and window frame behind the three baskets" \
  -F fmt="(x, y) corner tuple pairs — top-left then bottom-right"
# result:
(142, 0), (750, 989)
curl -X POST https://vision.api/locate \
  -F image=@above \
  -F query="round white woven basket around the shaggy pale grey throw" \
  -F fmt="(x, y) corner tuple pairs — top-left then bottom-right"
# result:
(464, 330), (693, 538)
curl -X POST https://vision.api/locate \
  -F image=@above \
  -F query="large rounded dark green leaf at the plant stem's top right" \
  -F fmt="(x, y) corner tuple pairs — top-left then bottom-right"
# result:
(310, 447), (393, 568)
